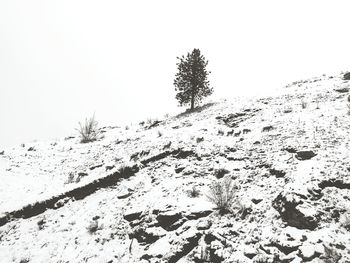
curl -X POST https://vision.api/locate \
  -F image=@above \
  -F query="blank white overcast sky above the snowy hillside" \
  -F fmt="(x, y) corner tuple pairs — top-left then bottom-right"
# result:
(0, 0), (350, 148)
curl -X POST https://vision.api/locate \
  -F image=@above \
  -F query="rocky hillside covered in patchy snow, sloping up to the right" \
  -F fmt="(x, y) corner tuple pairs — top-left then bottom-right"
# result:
(0, 75), (350, 263)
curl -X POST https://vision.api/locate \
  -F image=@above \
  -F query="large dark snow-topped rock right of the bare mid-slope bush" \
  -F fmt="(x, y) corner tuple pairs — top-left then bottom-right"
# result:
(272, 192), (320, 230)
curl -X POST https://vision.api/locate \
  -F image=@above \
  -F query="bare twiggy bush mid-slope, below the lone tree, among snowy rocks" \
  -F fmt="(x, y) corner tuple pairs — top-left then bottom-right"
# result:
(207, 177), (236, 214)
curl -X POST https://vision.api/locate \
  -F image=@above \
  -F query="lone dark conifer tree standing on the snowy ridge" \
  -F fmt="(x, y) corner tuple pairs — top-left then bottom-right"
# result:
(174, 48), (213, 110)
